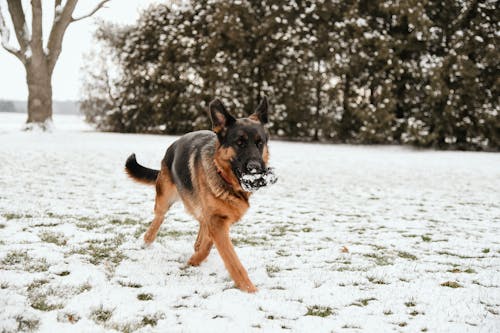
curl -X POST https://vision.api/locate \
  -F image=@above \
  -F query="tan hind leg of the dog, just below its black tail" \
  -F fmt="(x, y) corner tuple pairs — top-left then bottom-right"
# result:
(144, 168), (178, 245)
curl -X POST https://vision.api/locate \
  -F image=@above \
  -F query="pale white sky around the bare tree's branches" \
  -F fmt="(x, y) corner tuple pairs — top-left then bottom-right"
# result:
(0, 0), (160, 100)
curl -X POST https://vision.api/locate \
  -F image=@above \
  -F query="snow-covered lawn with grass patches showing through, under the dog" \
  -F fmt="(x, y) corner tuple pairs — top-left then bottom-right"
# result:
(0, 113), (500, 332)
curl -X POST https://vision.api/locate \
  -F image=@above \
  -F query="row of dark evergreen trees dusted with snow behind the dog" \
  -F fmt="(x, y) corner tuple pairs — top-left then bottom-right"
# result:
(81, 0), (500, 150)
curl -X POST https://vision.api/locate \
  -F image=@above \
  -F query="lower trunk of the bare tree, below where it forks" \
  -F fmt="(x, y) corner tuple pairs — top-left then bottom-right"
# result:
(26, 64), (52, 127)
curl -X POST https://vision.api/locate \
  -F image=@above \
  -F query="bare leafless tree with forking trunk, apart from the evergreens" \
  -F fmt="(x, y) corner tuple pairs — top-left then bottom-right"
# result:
(0, 0), (109, 129)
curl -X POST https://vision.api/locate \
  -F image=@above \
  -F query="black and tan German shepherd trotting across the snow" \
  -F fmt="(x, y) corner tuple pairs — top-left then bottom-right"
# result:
(125, 96), (269, 293)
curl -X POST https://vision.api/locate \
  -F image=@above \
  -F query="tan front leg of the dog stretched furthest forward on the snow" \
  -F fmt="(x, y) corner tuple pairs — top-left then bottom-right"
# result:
(208, 215), (257, 293)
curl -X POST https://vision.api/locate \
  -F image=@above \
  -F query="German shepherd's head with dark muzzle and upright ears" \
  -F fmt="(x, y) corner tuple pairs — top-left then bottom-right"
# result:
(209, 96), (269, 188)
